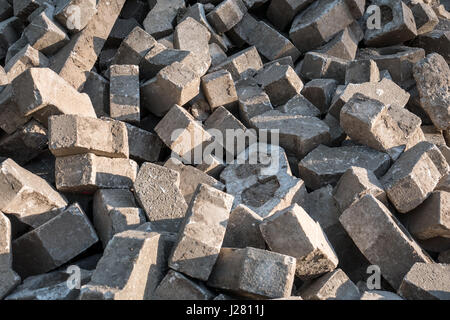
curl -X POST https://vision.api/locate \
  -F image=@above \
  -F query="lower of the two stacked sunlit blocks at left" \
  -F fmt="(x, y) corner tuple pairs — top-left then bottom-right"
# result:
(55, 153), (138, 194)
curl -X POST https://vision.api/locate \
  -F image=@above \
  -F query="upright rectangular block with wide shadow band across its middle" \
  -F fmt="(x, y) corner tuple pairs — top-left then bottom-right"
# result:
(109, 64), (141, 123)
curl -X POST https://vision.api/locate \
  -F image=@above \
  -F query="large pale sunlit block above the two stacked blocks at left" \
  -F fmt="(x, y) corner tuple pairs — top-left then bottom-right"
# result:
(11, 68), (96, 125)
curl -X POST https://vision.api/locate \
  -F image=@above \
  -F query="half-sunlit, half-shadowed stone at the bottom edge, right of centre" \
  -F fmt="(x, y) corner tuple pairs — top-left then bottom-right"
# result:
(298, 269), (361, 300)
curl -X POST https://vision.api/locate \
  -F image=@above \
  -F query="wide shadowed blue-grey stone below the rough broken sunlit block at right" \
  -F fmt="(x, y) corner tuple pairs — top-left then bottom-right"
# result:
(299, 145), (390, 190)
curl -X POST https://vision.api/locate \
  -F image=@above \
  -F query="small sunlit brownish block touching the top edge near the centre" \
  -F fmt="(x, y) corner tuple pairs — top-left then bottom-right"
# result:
(206, 0), (247, 33)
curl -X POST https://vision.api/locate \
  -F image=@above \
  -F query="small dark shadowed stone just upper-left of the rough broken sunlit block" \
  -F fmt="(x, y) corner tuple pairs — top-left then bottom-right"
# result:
(301, 79), (337, 114)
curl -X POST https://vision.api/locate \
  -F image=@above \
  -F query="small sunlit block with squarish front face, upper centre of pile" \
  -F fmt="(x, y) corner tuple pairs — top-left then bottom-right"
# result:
(202, 70), (238, 111)
